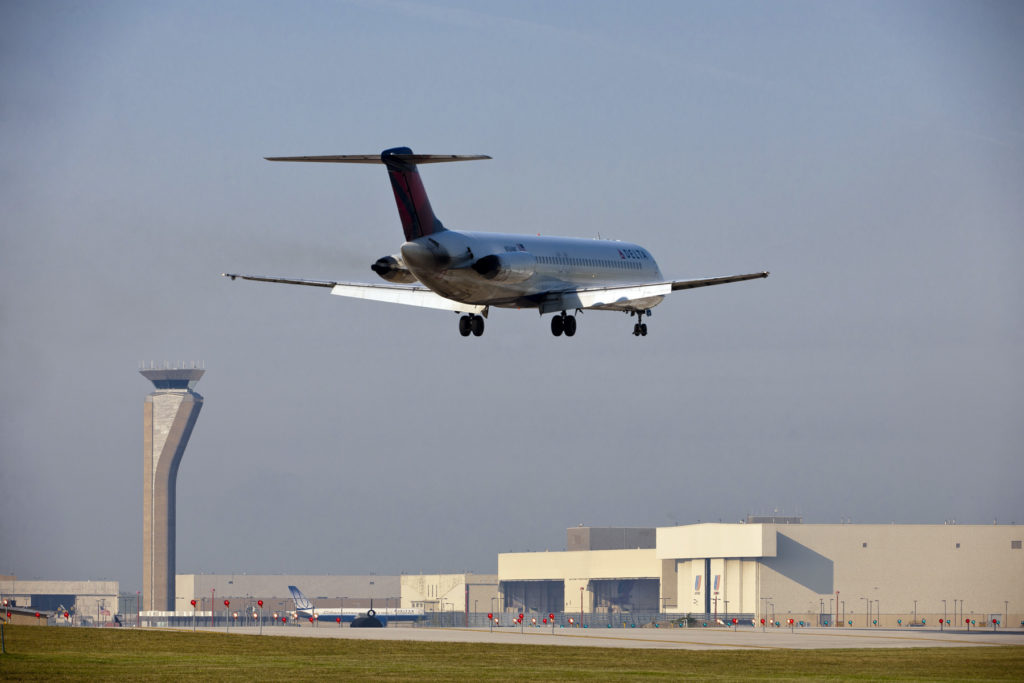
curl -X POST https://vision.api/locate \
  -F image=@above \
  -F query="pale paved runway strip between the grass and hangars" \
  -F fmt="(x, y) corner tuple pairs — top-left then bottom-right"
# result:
(200, 626), (1024, 650)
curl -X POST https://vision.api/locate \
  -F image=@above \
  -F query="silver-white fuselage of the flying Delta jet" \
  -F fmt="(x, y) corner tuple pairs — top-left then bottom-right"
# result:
(401, 230), (664, 309)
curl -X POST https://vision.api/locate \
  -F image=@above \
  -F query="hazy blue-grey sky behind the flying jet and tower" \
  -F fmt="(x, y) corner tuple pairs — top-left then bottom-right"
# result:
(0, 0), (1024, 590)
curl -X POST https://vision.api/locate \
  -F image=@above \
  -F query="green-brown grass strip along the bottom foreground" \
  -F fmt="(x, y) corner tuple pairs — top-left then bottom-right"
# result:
(0, 626), (1024, 681)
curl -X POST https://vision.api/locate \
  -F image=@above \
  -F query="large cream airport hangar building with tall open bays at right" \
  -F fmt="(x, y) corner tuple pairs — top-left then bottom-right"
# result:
(498, 517), (1024, 627)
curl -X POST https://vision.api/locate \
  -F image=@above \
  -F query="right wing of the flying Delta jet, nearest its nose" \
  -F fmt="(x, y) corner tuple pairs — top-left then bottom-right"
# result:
(540, 271), (768, 313)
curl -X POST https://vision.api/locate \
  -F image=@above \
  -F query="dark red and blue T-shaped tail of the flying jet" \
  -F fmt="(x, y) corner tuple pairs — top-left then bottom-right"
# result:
(266, 147), (490, 242)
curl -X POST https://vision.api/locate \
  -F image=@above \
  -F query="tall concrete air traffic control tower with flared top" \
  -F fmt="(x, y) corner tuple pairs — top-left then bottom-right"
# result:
(139, 367), (206, 611)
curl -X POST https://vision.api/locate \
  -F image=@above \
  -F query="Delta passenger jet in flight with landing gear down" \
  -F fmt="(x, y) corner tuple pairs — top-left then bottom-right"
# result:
(222, 147), (768, 337)
